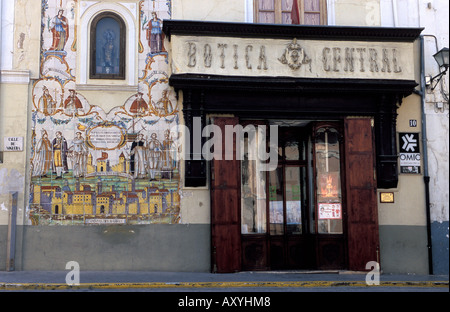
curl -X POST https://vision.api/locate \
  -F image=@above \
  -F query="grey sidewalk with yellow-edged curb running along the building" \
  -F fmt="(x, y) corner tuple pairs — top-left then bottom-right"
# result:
(0, 270), (449, 291)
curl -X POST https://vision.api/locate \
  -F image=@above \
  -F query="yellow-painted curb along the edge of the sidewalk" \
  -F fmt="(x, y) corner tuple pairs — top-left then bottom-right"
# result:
(0, 281), (449, 291)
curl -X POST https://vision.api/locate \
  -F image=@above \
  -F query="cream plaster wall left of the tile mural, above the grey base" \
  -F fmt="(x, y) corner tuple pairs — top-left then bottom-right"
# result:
(0, 0), (34, 225)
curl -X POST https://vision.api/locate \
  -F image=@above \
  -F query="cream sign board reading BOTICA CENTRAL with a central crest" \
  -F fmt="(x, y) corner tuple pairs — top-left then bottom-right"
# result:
(171, 35), (414, 80)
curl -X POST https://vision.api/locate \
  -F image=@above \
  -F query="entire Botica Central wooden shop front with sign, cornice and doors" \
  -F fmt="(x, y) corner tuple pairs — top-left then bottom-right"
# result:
(164, 20), (421, 272)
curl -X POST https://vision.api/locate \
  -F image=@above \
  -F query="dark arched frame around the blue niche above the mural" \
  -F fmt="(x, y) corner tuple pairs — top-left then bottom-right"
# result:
(89, 12), (126, 80)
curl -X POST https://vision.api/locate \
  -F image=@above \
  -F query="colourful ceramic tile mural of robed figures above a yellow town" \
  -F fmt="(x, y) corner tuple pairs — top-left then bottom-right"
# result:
(28, 0), (180, 225)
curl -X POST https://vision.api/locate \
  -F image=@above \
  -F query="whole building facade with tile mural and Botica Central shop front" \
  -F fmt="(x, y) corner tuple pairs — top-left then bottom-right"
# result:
(0, 0), (448, 274)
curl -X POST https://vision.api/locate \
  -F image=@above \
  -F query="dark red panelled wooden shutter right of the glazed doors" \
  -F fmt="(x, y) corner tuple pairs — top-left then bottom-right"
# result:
(345, 118), (379, 271)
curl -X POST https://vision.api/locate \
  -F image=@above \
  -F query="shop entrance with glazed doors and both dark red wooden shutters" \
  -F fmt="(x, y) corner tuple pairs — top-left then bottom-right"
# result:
(211, 118), (378, 272)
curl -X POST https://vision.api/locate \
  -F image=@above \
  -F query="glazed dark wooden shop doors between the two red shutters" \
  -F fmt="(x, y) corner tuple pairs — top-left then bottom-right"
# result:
(241, 122), (346, 270)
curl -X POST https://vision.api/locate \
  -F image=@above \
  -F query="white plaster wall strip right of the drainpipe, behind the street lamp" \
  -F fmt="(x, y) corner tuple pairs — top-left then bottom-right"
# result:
(419, 0), (449, 222)
